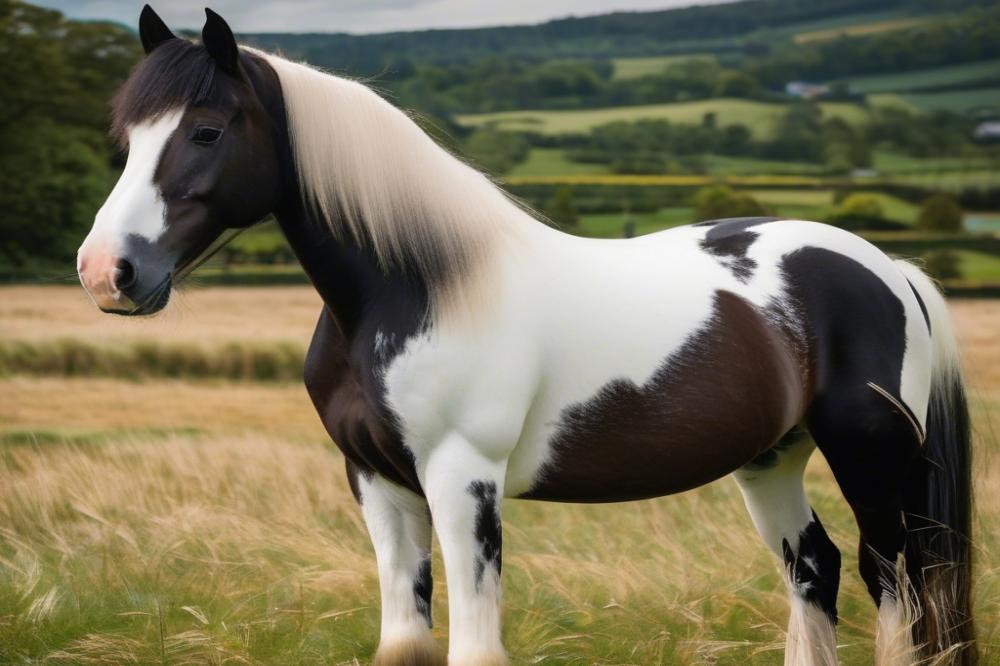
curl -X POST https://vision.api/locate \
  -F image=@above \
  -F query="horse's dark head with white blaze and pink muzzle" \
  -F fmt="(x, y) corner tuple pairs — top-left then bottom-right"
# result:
(77, 5), (281, 314)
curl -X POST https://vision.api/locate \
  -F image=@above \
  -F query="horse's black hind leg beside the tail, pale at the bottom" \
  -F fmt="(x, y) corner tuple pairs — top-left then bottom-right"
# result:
(809, 385), (920, 666)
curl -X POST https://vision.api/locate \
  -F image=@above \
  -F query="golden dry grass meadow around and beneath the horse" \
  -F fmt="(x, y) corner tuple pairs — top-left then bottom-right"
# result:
(0, 286), (1000, 666)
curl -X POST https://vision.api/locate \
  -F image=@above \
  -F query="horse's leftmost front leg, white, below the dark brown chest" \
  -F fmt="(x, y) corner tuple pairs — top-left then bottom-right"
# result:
(348, 465), (445, 666)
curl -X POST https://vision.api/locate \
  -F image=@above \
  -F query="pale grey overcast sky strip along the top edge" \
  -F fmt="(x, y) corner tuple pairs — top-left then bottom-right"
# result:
(32, 0), (728, 32)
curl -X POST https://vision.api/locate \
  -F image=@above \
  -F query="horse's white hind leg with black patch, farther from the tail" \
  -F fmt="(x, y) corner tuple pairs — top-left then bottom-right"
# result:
(733, 429), (840, 666)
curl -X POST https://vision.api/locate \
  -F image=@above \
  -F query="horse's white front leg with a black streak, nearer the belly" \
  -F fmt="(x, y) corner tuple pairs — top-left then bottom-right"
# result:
(424, 434), (508, 666)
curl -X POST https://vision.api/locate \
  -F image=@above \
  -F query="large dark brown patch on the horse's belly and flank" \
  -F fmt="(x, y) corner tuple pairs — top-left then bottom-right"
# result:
(522, 291), (808, 502)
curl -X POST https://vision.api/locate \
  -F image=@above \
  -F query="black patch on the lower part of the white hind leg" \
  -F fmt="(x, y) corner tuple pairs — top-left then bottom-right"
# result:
(781, 511), (840, 624)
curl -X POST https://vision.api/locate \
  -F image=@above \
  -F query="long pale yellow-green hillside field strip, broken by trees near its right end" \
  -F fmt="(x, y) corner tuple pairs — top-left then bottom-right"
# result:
(455, 98), (867, 138)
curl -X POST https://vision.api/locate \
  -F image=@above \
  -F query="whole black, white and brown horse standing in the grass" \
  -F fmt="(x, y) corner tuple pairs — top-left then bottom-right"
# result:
(78, 5), (976, 666)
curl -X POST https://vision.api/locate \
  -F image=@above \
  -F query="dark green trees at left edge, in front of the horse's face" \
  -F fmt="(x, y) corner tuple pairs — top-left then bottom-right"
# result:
(0, 0), (142, 270)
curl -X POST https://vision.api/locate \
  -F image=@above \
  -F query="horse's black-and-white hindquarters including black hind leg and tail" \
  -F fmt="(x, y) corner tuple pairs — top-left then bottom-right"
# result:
(784, 248), (975, 665)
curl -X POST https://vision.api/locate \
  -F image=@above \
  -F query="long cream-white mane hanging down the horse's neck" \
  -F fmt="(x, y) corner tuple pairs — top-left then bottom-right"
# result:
(254, 51), (528, 316)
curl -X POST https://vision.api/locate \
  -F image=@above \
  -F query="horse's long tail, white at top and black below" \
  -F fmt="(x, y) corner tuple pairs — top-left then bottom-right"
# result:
(896, 261), (977, 666)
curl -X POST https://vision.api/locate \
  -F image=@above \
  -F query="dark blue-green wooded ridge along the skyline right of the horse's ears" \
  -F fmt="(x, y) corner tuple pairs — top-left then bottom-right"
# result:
(242, 0), (976, 75)
